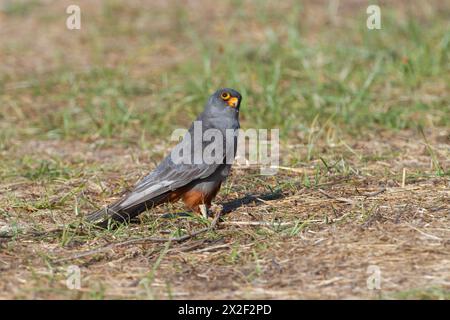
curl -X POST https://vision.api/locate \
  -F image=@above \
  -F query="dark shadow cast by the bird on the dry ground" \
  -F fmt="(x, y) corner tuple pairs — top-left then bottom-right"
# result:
(162, 192), (285, 219)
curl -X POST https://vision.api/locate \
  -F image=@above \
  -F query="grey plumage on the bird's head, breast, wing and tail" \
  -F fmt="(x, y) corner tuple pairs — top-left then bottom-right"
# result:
(86, 88), (242, 225)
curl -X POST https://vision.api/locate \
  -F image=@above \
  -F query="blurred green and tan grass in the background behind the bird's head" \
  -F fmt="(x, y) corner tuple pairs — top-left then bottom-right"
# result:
(0, 0), (450, 149)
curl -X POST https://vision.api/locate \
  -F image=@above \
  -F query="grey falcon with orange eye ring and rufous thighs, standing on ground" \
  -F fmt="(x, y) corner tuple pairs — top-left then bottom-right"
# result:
(85, 88), (242, 226)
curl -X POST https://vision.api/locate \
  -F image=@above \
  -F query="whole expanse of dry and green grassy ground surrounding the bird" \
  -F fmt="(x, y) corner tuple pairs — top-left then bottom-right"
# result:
(0, 0), (450, 299)
